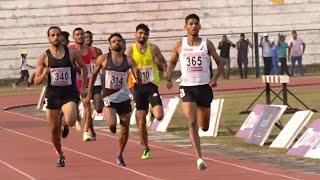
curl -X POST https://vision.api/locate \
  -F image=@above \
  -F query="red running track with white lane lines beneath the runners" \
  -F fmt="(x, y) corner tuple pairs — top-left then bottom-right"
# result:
(0, 96), (319, 180)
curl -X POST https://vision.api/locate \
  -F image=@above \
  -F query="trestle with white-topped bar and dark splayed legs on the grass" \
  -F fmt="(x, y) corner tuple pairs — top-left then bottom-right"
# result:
(240, 75), (318, 114)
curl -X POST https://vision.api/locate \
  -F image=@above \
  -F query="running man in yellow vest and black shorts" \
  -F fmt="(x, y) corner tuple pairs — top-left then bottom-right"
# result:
(126, 24), (167, 159)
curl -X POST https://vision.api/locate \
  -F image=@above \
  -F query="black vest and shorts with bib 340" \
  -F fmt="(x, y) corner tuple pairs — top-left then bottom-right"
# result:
(46, 48), (79, 109)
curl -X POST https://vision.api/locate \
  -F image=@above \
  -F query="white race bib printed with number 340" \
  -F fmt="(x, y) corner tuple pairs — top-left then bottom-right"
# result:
(50, 67), (72, 86)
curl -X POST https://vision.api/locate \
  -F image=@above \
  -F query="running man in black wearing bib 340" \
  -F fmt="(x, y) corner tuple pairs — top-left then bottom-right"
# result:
(34, 26), (87, 167)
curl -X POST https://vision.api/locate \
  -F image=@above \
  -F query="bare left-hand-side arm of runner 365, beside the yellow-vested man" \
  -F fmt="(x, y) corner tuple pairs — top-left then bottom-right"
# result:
(163, 40), (182, 89)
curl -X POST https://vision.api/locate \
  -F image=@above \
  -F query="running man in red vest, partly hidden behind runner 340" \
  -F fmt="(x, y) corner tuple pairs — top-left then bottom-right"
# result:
(70, 27), (97, 141)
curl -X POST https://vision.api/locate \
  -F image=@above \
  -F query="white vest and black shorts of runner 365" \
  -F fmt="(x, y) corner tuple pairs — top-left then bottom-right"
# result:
(179, 37), (213, 108)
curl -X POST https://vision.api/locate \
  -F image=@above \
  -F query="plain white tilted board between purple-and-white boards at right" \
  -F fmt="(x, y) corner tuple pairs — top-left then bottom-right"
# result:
(270, 110), (313, 149)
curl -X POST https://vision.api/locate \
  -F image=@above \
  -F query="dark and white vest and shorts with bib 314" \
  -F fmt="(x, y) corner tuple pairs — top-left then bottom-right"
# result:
(102, 53), (132, 115)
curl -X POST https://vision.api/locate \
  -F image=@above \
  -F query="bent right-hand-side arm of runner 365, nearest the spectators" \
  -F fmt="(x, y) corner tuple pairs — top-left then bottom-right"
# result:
(207, 40), (223, 87)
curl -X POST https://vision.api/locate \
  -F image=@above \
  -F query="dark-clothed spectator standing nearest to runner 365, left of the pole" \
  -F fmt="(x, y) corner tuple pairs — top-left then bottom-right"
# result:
(218, 35), (236, 79)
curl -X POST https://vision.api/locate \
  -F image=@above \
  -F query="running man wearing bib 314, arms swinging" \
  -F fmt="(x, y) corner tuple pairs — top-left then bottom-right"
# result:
(86, 33), (140, 166)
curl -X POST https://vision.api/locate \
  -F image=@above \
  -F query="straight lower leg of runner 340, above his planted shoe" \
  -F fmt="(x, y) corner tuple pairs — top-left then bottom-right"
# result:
(46, 109), (63, 155)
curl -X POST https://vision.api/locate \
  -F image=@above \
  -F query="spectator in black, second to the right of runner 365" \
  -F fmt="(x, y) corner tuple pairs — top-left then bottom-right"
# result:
(237, 33), (252, 79)
